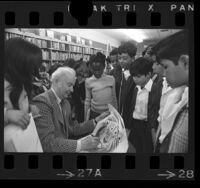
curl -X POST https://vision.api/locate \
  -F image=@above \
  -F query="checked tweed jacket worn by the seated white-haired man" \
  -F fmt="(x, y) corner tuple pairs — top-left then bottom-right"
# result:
(33, 90), (94, 152)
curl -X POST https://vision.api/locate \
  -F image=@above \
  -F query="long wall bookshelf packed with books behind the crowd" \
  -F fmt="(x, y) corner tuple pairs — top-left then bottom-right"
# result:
(5, 28), (107, 68)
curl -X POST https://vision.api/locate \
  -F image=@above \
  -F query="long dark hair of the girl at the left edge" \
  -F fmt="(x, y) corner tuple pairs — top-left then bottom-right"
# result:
(4, 38), (42, 109)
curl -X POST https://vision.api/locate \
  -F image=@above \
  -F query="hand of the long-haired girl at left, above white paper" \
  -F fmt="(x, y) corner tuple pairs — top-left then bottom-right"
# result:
(6, 109), (30, 129)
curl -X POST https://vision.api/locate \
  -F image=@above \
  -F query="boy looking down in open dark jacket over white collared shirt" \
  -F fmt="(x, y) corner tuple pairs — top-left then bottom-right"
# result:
(126, 57), (161, 153)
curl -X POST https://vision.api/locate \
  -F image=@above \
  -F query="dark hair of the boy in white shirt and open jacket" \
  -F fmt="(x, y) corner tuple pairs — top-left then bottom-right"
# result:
(130, 57), (153, 76)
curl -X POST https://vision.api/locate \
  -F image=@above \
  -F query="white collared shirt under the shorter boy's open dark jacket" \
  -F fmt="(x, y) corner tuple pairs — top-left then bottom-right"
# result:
(133, 79), (153, 120)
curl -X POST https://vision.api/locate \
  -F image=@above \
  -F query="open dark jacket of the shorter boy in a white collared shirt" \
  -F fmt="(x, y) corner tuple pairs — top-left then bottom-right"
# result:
(124, 79), (162, 129)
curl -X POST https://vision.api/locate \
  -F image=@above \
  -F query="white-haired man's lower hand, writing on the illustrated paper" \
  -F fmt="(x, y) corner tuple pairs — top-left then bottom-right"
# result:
(80, 135), (99, 151)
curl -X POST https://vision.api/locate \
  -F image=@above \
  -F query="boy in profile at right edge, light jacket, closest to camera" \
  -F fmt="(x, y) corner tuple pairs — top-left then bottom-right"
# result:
(153, 30), (189, 153)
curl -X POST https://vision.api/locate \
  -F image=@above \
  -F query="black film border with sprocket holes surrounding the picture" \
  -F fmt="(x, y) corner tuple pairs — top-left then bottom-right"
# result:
(0, 1), (196, 180)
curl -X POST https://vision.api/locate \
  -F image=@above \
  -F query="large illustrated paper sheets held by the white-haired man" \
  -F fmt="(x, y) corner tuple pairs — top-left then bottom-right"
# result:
(82, 104), (128, 153)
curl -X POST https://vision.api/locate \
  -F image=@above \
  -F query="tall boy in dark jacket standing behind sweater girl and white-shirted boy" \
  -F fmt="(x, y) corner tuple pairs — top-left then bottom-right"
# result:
(118, 41), (137, 118)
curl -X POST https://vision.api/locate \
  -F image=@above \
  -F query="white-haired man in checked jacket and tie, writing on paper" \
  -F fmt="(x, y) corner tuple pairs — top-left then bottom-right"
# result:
(33, 67), (108, 152)
